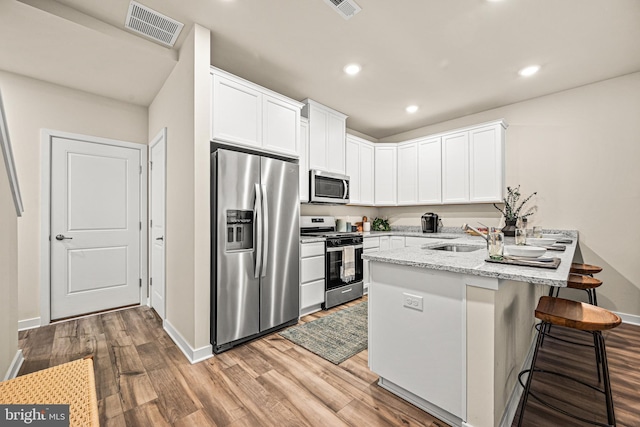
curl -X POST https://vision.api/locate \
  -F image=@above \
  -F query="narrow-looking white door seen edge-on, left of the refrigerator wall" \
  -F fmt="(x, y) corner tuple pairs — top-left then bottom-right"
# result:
(149, 130), (166, 319)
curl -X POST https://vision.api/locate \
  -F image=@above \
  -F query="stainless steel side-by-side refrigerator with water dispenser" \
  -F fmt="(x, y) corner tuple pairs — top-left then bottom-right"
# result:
(211, 149), (300, 353)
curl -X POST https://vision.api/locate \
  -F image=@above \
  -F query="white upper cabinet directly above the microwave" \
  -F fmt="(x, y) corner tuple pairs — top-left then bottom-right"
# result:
(302, 99), (347, 174)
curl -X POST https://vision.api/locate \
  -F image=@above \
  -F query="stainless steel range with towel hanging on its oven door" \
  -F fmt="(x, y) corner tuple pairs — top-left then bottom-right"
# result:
(300, 216), (363, 310)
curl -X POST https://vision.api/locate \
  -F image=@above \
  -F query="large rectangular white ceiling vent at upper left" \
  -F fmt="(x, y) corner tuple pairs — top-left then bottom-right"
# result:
(124, 1), (184, 47)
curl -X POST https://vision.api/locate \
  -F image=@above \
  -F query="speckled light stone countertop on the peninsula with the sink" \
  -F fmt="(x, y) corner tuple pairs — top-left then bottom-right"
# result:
(362, 230), (578, 287)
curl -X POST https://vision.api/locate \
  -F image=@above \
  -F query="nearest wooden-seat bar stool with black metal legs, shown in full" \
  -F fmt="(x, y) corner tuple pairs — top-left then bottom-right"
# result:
(518, 296), (621, 427)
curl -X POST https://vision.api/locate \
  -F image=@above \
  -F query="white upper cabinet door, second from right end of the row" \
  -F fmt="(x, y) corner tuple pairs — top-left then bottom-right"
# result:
(442, 132), (469, 203)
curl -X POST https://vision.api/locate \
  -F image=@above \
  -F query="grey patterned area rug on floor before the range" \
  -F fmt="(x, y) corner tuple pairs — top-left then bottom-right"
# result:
(280, 302), (368, 365)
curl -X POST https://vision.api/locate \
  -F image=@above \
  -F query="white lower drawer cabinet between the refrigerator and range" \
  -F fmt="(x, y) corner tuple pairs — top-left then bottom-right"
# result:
(300, 242), (325, 316)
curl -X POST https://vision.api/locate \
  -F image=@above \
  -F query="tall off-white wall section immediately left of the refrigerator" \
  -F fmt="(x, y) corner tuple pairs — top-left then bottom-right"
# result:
(149, 25), (211, 356)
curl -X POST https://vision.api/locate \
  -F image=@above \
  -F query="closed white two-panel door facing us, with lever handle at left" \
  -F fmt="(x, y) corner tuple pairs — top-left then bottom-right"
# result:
(50, 137), (142, 320)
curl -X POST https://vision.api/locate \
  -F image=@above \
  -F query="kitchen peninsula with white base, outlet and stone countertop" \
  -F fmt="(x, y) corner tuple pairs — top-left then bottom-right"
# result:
(363, 231), (578, 427)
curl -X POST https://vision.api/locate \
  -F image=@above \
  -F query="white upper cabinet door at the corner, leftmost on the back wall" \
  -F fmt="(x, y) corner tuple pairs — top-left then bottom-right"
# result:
(374, 144), (398, 206)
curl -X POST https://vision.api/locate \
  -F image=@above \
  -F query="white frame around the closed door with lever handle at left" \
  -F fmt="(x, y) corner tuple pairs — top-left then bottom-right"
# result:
(40, 129), (148, 326)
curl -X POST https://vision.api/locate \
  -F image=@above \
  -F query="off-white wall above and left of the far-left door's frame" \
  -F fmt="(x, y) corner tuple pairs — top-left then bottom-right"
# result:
(0, 71), (147, 320)
